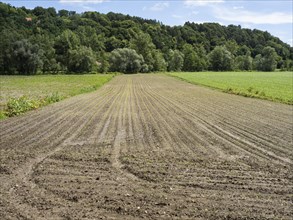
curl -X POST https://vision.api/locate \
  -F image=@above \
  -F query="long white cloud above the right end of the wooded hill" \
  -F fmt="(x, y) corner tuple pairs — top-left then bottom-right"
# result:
(214, 7), (292, 24)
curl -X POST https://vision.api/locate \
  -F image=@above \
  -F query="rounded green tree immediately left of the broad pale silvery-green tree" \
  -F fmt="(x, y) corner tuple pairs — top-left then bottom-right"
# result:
(68, 46), (96, 73)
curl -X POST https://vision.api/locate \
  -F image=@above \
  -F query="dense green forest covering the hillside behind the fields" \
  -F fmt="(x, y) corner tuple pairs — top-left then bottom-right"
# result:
(0, 3), (293, 75)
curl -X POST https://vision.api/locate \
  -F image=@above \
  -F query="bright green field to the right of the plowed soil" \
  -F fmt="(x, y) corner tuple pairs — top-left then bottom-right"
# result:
(167, 72), (293, 104)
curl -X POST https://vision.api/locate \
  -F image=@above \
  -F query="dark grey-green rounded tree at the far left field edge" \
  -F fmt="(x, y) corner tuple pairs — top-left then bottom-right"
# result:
(13, 39), (43, 74)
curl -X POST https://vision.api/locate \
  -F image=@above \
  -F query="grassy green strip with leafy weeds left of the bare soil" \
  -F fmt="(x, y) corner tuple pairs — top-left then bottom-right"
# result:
(0, 74), (115, 119)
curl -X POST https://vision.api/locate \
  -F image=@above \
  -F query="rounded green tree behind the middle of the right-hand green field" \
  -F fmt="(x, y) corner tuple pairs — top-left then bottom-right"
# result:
(209, 46), (233, 71)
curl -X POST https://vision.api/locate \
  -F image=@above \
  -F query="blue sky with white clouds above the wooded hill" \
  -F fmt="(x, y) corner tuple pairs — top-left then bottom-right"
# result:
(1, 0), (293, 46)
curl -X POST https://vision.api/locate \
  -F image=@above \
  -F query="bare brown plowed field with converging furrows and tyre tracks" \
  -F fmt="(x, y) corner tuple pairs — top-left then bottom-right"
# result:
(0, 75), (293, 219)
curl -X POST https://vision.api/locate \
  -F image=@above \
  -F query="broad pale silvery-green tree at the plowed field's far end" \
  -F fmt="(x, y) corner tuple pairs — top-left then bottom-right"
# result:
(110, 48), (144, 73)
